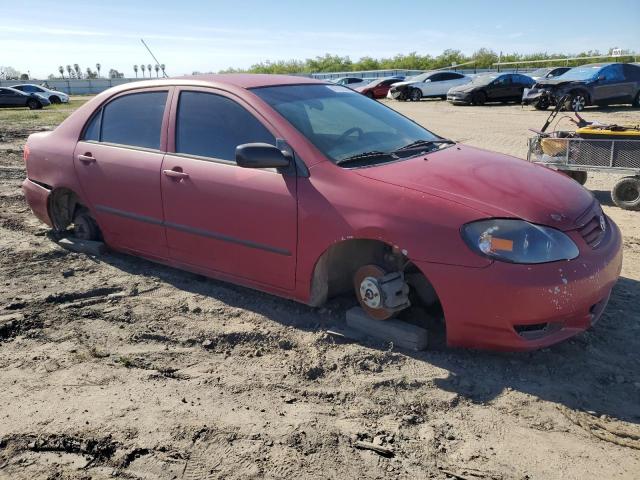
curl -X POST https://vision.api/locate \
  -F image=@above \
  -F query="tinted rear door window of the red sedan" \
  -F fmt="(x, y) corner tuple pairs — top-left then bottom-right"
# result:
(98, 92), (167, 150)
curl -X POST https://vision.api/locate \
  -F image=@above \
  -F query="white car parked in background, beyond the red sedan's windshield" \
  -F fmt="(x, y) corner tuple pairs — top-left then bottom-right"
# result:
(387, 71), (471, 101)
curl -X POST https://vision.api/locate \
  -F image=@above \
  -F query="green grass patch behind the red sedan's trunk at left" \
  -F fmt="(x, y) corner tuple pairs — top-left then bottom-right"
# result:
(0, 96), (93, 130)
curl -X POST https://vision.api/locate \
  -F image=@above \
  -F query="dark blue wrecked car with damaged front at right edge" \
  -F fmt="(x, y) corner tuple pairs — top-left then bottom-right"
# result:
(522, 63), (640, 112)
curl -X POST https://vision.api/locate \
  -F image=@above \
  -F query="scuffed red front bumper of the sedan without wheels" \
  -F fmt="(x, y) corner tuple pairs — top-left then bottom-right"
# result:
(416, 216), (622, 351)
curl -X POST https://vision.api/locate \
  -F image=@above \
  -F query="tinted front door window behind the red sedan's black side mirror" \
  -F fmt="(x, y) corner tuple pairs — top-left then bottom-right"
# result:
(176, 92), (276, 161)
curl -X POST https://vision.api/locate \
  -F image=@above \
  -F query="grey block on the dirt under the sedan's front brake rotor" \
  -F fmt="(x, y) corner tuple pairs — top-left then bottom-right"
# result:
(347, 307), (428, 351)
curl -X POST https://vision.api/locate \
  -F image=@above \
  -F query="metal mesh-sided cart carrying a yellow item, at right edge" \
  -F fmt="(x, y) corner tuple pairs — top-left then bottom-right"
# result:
(527, 132), (640, 210)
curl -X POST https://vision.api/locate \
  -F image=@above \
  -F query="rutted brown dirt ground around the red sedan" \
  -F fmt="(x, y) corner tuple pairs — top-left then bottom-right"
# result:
(0, 97), (640, 480)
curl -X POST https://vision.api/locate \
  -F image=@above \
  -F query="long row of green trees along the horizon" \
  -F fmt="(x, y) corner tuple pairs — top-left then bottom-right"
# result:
(220, 48), (631, 73)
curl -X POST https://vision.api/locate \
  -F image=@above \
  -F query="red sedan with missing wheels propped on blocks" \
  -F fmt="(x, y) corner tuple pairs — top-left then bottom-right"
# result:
(23, 75), (622, 350)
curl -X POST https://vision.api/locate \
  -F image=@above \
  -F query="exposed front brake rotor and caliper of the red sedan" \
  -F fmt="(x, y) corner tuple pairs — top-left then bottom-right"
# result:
(354, 265), (410, 320)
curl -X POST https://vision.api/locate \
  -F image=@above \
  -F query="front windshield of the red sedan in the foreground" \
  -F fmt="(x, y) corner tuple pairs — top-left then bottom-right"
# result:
(252, 85), (442, 166)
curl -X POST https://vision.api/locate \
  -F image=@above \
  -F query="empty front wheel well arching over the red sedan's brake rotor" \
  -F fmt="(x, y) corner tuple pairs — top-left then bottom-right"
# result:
(308, 239), (439, 306)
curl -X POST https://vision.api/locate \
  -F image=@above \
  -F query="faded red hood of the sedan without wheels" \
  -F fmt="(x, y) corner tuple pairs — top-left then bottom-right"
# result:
(354, 145), (595, 230)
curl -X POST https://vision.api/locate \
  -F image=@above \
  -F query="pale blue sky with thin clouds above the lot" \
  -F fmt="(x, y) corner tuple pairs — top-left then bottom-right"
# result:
(0, 0), (640, 78)
